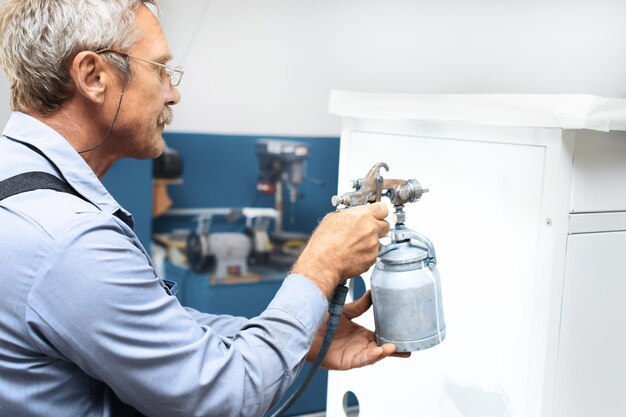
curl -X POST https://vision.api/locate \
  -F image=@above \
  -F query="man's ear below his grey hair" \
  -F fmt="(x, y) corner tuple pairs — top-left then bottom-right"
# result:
(70, 51), (111, 104)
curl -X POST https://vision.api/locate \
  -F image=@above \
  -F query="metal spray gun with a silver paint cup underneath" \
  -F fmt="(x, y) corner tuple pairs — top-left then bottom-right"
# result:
(331, 162), (446, 352)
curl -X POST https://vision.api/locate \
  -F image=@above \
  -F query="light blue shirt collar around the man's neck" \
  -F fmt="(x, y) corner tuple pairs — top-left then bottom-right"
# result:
(3, 112), (131, 216)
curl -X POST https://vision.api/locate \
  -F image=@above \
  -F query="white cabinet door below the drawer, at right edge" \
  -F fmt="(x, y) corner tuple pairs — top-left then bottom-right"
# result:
(555, 232), (626, 417)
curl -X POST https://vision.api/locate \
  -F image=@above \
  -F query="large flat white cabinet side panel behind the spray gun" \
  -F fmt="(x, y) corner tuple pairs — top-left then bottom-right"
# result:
(327, 128), (546, 417)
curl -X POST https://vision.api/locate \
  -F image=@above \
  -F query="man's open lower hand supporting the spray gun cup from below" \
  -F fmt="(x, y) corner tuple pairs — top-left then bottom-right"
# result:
(307, 291), (411, 370)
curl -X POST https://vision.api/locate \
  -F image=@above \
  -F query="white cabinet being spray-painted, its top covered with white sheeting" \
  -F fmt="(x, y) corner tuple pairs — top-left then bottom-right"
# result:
(327, 94), (626, 417)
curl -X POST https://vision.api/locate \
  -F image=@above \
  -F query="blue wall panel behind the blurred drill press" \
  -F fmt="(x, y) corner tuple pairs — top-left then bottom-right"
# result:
(154, 133), (339, 233)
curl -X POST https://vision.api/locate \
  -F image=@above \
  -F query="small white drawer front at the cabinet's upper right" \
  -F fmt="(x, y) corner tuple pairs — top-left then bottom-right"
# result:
(572, 130), (626, 213)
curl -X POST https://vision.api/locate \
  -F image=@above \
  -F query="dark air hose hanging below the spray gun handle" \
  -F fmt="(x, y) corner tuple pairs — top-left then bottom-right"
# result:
(271, 284), (348, 417)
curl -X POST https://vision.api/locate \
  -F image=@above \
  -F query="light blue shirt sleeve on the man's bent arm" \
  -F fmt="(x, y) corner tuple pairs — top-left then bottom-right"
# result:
(27, 217), (328, 417)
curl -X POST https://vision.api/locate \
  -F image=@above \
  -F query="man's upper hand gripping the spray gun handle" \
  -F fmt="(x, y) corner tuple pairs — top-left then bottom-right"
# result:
(291, 203), (389, 299)
